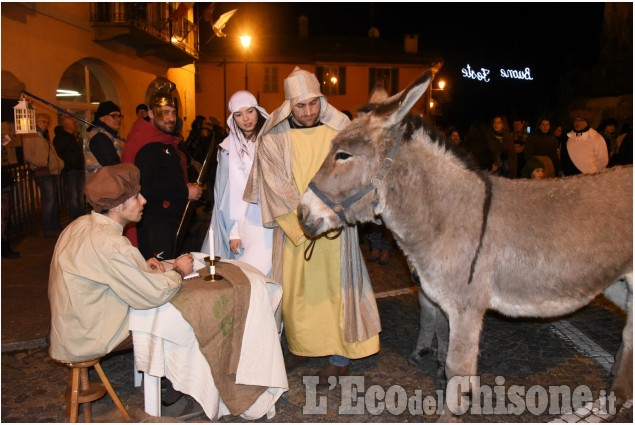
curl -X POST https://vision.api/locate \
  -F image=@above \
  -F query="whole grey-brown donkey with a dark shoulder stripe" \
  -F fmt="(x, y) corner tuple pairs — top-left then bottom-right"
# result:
(298, 71), (633, 420)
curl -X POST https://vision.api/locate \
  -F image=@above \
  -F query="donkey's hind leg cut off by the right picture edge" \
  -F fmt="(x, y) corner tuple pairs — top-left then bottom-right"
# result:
(611, 273), (633, 407)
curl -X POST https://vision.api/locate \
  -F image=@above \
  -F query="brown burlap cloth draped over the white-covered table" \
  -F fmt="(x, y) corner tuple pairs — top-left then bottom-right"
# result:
(171, 262), (267, 416)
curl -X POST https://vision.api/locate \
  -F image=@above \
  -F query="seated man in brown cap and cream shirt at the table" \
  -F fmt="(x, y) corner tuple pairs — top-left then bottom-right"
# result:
(48, 164), (193, 361)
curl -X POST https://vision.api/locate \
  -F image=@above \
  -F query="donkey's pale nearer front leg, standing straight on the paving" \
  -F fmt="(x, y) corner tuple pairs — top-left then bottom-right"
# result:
(439, 307), (484, 422)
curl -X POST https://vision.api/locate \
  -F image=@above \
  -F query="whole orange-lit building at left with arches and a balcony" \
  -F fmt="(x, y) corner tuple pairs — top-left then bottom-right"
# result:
(1, 2), (198, 142)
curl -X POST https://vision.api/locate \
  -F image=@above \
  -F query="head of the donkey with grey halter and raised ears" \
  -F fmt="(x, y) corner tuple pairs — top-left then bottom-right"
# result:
(298, 70), (432, 236)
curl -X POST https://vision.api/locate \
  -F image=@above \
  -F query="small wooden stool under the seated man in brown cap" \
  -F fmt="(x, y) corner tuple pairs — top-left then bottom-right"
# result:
(54, 358), (131, 422)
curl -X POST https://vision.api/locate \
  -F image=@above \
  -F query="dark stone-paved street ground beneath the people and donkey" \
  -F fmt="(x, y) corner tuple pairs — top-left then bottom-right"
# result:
(1, 225), (633, 423)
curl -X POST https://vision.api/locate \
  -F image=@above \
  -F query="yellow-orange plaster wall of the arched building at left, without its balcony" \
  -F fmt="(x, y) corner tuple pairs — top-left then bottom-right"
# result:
(1, 2), (196, 137)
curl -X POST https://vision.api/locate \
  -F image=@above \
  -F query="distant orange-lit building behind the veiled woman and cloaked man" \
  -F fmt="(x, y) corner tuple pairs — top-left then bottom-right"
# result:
(196, 35), (443, 122)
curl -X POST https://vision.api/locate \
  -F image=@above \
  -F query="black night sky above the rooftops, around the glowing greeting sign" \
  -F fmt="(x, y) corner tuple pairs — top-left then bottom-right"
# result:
(206, 2), (604, 127)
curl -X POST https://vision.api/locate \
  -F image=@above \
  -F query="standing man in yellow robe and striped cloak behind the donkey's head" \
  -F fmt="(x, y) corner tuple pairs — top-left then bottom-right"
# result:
(244, 67), (381, 385)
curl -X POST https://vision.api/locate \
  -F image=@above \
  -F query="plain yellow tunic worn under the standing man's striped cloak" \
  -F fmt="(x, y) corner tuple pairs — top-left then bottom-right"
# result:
(276, 125), (379, 359)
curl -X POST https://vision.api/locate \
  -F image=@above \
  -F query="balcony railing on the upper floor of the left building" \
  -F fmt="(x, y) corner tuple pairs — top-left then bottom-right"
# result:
(90, 2), (199, 59)
